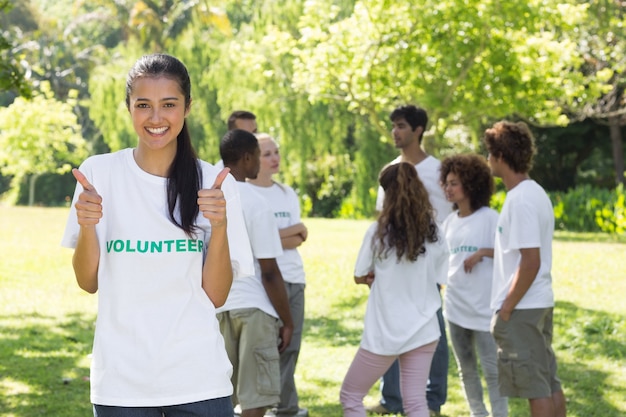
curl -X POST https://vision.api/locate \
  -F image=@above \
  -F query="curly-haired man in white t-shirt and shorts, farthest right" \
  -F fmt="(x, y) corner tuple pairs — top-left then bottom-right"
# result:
(484, 122), (566, 417)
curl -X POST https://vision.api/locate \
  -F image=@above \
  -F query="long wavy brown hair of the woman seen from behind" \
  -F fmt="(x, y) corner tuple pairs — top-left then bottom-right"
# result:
(374, 162), (438, 262)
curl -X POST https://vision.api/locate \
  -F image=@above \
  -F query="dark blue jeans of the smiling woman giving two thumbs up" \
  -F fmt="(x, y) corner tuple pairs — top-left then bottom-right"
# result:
(93, 397), (234, 417)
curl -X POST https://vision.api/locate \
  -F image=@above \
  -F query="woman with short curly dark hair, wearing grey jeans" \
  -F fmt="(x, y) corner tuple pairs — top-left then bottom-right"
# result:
(440, 154), (508, 417)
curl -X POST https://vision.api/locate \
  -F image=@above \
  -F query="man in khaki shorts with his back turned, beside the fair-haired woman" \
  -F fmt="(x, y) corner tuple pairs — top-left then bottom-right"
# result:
(217, 129), (293, 417)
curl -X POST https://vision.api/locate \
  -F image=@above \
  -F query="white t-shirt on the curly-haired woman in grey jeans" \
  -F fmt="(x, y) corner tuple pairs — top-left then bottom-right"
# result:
(443, 207), (498, 332)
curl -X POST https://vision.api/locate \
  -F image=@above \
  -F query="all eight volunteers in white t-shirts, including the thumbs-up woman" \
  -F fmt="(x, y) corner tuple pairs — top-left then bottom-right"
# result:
(62, 54), (565, 417)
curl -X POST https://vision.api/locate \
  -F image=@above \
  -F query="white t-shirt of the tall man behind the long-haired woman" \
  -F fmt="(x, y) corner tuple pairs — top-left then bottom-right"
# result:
(376, 155), (452, 225)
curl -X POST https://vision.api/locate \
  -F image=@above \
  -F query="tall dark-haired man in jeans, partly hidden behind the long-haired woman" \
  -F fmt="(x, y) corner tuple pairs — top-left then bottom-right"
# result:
(368, 105), (452, 416)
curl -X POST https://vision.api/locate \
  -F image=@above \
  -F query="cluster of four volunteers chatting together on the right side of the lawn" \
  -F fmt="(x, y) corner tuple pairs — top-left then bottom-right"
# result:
(340, 105), (566, 417)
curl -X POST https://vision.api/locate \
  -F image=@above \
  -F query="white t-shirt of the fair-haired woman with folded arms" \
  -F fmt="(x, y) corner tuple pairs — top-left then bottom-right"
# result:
(250, 183), (306, 284)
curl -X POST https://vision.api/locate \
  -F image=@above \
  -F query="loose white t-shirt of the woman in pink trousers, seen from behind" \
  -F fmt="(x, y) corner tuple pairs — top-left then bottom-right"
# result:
(354, 223), (448, 355)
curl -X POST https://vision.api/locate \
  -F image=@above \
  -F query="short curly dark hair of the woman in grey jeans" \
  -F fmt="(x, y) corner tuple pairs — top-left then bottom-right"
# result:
(439, 154), (494, 212)
